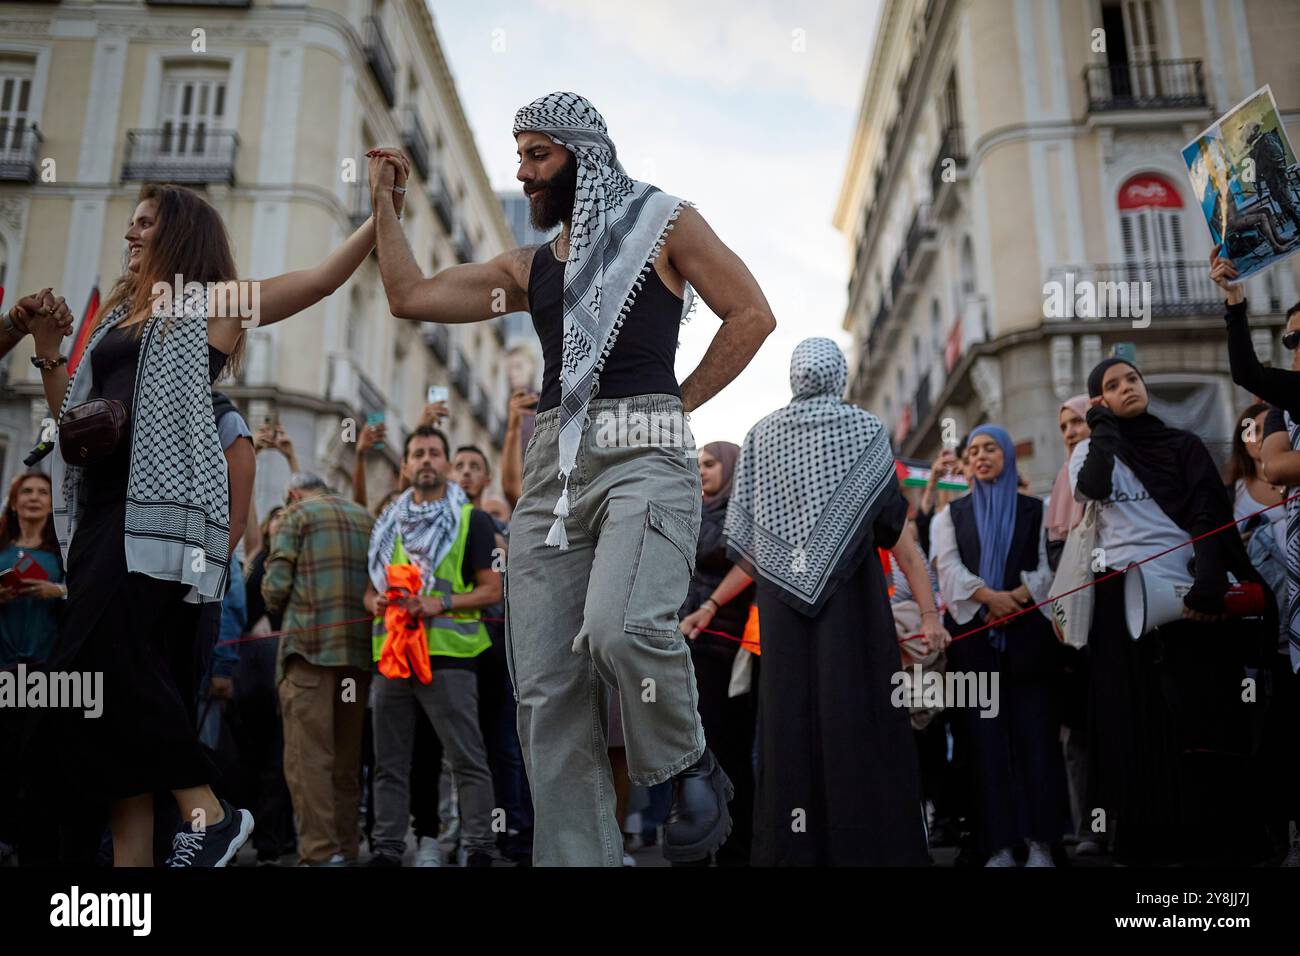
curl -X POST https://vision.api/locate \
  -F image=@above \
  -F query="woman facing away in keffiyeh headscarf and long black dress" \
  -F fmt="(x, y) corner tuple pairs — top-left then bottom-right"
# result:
(720, 338), (949, 866)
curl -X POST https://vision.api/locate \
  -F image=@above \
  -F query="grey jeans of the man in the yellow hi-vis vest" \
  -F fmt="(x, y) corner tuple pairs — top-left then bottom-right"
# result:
(371, 669), (495, 857)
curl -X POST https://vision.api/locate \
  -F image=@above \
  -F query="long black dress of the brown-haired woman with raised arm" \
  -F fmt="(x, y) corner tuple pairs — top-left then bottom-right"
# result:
(36, 328), (228, 804)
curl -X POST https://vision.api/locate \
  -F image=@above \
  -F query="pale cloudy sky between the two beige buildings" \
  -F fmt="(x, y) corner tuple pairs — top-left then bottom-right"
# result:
(428, 0), (879, 445)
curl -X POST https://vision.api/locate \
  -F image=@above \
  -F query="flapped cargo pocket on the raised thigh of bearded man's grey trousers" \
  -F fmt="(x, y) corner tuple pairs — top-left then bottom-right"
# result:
(623, 501), (696, 644)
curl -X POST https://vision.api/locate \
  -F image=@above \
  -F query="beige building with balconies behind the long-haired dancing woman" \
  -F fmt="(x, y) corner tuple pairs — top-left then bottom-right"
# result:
(0, 0), (515, 510)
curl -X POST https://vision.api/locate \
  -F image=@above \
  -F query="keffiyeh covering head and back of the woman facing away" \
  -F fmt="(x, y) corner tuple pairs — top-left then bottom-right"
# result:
(724, 338), (897, 615)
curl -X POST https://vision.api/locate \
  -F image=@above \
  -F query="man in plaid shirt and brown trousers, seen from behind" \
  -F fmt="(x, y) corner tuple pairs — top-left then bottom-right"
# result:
(261, 473), (373, 866)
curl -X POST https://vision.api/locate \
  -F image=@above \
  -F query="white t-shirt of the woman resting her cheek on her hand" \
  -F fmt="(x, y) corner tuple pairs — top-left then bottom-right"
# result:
(1070, 438), (1192, 579)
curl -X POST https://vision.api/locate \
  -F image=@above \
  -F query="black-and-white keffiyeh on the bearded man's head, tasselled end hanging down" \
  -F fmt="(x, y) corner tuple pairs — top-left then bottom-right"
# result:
(514, 92), (693, 550)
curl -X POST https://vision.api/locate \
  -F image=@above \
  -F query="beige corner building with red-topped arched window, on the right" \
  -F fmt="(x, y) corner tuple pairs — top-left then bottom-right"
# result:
(835, 0), (1300, 493)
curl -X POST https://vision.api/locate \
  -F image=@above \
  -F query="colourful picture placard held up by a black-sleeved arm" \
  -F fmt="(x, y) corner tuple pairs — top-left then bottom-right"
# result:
(1183, 86), (1300, 278)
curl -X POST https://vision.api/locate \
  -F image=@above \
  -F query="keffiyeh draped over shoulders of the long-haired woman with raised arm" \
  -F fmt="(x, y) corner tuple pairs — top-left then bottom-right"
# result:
(51, 283), (230, 602)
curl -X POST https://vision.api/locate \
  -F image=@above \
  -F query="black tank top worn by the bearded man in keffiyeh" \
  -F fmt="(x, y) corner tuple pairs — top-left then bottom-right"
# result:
(528, 242), (683, 411)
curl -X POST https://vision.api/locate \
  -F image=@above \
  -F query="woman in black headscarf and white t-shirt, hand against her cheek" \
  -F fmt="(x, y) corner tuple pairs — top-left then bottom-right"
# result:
(1070, 359), (1277, 864)
